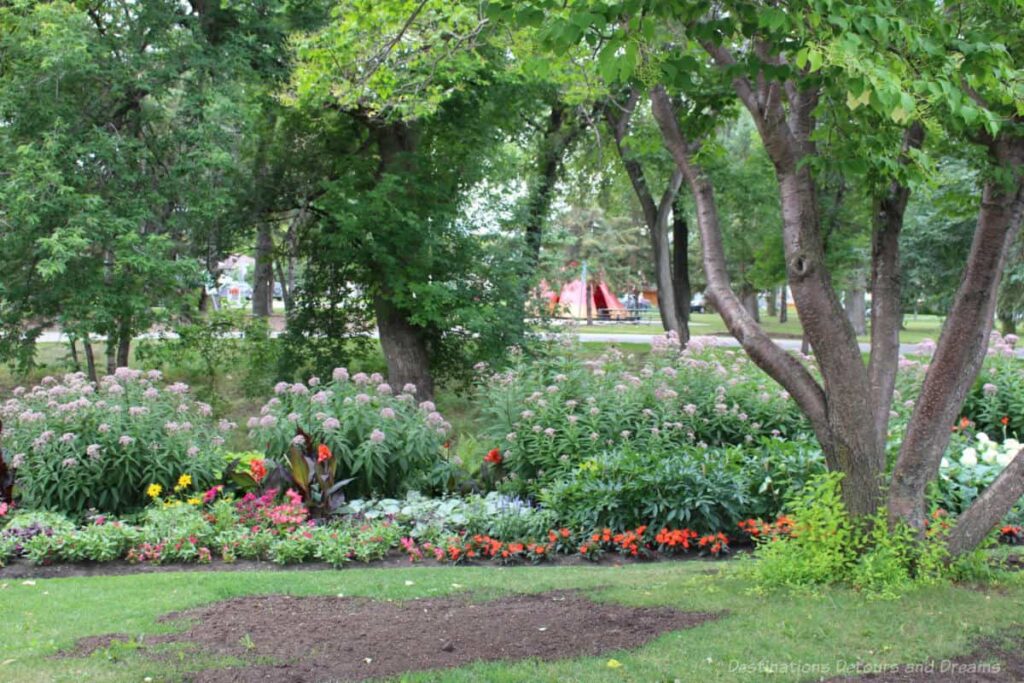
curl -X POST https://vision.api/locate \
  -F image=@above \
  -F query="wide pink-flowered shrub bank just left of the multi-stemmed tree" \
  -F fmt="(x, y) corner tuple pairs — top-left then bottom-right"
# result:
(476, 338), (807, 493)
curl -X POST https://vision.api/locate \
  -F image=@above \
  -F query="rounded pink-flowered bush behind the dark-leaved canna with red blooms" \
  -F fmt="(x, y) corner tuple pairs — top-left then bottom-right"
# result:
(249, 368), (451, 497)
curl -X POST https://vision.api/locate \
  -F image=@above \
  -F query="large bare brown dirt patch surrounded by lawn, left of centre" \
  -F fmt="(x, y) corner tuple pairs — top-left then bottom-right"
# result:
(71, 592), (720, 683)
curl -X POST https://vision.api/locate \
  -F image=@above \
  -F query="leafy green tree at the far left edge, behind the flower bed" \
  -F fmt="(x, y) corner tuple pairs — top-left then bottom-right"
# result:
(0, 2), (254, 377)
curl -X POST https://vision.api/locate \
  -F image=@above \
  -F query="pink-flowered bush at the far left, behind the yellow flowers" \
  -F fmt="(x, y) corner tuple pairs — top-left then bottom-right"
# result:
(0, 368), (233, 517)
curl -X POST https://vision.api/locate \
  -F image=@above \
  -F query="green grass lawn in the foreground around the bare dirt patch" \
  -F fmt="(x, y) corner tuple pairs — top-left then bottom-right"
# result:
(0, 561), (1024, 683)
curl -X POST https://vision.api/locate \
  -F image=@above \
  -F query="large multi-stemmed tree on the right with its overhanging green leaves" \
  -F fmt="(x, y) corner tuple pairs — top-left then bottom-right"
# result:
(495, 0), (1024, 553)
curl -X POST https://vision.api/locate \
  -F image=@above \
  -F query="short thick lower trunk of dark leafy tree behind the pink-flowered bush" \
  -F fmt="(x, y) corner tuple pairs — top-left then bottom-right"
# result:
(374, 295), (434, 399)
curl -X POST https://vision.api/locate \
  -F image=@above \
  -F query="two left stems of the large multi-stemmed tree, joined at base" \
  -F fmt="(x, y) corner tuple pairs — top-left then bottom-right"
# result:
(653, 69), (885, 516)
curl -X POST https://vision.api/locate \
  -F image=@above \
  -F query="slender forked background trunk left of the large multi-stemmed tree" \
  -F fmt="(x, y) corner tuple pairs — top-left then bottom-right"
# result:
(605, 89), (688, 339)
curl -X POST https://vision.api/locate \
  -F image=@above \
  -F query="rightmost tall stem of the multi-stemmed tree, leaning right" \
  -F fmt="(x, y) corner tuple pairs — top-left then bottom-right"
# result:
(889, 136), (1024, 528)
